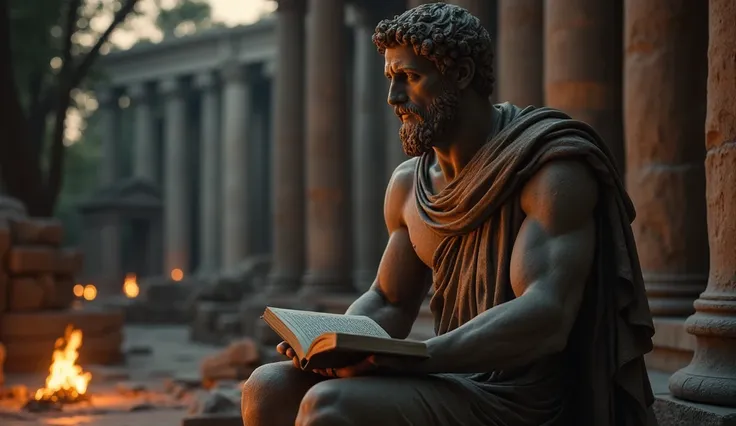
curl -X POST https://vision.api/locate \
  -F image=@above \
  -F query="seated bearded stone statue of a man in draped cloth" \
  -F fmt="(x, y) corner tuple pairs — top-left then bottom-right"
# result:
(242, 3), (656, 426)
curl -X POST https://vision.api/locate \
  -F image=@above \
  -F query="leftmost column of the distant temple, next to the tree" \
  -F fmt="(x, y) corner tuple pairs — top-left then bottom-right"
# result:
(95, 88), (121, 187)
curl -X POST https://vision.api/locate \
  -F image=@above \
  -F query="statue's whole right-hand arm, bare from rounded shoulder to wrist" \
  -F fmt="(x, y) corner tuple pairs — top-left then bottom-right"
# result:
(425, 161), (598, 372)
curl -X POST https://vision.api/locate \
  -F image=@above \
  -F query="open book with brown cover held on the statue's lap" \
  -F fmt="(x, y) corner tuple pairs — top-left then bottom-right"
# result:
(262, 307), (429, 370)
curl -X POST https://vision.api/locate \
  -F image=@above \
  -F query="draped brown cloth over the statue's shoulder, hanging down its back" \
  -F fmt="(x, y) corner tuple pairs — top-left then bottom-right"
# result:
(415, 103), (656, 426)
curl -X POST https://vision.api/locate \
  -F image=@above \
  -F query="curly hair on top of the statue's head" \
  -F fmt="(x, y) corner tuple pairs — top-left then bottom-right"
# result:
(372, 3), (495, 96)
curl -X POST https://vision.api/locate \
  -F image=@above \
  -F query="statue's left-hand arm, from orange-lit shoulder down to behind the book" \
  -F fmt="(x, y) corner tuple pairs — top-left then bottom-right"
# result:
(346, 160), (430, 339)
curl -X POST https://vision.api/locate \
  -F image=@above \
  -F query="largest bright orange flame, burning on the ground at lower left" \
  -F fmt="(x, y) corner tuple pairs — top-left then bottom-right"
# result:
(34, 324), (92, 402)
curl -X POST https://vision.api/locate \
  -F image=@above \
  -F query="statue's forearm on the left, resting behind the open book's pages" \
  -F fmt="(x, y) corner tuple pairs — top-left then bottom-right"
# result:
(345, 288), (416, 339)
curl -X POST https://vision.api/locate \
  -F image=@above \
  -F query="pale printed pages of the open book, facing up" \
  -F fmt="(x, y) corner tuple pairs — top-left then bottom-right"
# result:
(270, 308), (391, 350)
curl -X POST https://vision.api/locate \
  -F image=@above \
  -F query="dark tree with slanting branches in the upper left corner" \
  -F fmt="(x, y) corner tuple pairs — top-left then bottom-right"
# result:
(0, 0), (138, 216)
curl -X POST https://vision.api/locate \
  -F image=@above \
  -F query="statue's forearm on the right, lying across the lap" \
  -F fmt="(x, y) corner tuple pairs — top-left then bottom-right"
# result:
(426, 295), (566, 373)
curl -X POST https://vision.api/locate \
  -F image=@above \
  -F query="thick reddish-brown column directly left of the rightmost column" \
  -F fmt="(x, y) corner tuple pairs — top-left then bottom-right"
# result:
(624, 0), (708, 317)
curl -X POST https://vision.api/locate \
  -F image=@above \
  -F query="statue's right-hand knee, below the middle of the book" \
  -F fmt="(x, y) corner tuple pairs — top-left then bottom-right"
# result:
(296, 380), (348, 426)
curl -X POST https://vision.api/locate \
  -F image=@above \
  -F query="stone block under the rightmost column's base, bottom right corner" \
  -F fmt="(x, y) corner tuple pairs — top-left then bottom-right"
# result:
(654, 395), (736, 426)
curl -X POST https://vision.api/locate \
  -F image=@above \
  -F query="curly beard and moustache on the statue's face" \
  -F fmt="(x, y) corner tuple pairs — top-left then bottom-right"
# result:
(395, 89), (459, 157)
